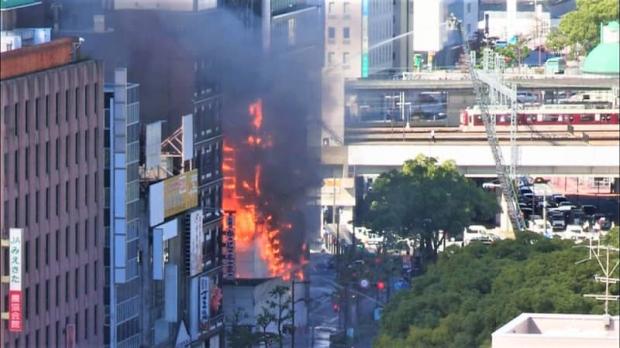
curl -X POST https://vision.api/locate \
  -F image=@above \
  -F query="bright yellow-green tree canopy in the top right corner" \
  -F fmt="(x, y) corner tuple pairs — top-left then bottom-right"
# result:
(547, 0), (619, 55)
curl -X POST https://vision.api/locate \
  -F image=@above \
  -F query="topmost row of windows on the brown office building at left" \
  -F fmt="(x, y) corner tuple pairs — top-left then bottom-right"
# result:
(4, 83), (99, 136)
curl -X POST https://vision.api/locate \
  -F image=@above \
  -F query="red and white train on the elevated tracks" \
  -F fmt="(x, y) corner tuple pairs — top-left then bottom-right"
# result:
(461, 104), (619, 131)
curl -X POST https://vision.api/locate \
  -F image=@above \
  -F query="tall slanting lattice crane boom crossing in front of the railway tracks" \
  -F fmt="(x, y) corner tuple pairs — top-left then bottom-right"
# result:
(451, 15), (525, 232)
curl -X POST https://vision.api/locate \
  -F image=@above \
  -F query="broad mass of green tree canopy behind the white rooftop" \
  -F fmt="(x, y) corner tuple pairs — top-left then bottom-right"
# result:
(375, 233), (618, 348)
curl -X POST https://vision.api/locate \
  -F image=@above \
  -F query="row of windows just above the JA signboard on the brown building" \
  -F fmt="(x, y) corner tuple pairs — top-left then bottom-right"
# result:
(4, 172), (99, 228)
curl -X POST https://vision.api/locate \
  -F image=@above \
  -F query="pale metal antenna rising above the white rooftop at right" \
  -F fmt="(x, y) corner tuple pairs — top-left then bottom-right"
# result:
(575, 239), (620, 316)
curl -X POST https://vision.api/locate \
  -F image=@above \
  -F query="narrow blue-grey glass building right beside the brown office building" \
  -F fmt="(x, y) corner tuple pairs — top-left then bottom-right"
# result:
(104, 68), (148, 347)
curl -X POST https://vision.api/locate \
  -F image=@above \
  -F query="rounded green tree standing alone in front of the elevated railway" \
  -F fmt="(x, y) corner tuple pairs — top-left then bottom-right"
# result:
(362, 155), (498, 260)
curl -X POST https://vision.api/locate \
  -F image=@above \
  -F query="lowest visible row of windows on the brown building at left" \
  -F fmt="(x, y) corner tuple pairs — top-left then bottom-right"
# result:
(4, 305), (99, 348)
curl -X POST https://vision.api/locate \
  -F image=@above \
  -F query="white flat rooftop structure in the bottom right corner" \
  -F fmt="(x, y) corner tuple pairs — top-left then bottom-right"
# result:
(492, 313), (620, 348)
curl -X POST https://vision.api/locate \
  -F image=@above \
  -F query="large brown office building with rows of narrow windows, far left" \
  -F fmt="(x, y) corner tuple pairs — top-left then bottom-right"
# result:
(0, 38), (105, 347)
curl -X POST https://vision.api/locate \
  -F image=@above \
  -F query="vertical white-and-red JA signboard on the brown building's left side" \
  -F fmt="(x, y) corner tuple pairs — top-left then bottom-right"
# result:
(9, 228), (23, 332)
